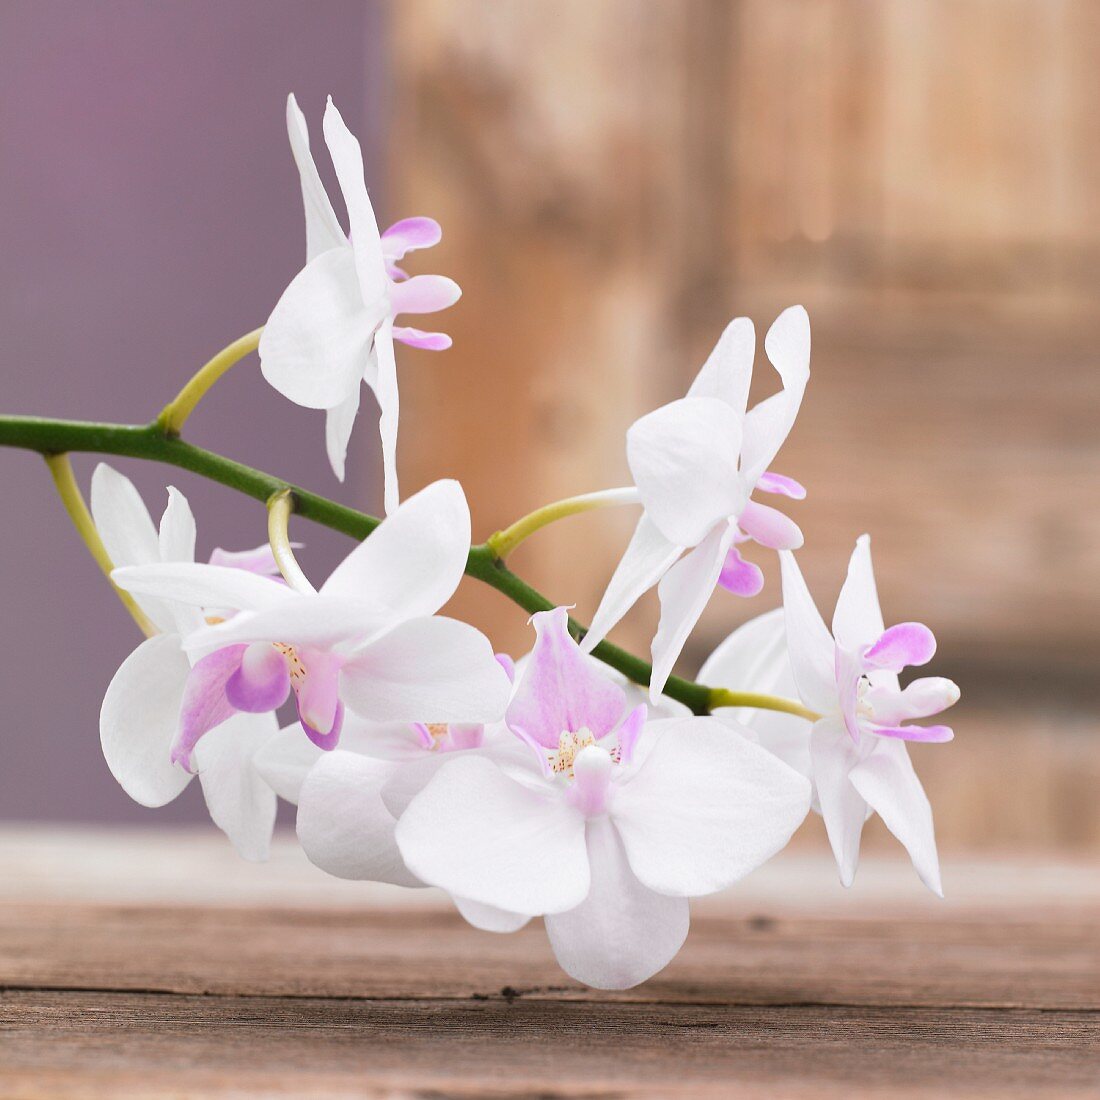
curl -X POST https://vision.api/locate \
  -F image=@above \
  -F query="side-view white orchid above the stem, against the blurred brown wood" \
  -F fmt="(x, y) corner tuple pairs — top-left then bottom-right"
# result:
(583, 306), (810, 701)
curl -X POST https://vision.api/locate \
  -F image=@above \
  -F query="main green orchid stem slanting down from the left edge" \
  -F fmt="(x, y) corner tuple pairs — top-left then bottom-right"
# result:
(0, 416), (811, 717)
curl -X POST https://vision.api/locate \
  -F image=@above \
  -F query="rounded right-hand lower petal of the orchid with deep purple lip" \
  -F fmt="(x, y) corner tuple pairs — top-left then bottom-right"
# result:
(340, 617), (512, 723)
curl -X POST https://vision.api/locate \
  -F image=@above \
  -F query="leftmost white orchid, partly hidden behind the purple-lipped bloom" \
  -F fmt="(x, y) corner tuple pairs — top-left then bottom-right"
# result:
(91, 463), (288, 860)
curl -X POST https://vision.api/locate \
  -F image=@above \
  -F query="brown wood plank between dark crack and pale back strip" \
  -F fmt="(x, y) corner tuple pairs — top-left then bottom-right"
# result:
(0, 905), (1100, 1012)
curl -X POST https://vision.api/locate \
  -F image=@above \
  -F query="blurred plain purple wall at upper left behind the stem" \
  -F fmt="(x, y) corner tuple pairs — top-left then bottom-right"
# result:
(0, 0), (385, 822)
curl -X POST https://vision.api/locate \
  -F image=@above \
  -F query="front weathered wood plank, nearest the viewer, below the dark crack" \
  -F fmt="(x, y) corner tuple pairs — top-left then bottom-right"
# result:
(0, 992), (1100, 1097)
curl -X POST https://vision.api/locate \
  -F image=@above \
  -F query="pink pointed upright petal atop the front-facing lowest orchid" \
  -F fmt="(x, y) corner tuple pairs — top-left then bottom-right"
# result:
(506, 607), (626, 749)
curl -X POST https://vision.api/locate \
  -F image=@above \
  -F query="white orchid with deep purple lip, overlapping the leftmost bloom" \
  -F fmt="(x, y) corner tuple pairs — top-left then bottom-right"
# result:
(112, 481), (509, 768)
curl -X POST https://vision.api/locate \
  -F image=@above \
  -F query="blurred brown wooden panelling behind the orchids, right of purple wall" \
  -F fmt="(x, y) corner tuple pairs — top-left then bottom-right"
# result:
(388, 0), (1100, 850)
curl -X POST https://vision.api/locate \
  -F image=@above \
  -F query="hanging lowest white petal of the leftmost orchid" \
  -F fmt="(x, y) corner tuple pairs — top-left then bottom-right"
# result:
(194, 714), (278, 862)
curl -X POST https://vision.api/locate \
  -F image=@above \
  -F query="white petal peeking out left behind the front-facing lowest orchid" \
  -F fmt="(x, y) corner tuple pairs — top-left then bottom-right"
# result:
(298, 749), (421, 887)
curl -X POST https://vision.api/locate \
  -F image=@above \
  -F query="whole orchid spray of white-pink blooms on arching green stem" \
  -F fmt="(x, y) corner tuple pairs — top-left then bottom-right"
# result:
(0, 96), (959, 989)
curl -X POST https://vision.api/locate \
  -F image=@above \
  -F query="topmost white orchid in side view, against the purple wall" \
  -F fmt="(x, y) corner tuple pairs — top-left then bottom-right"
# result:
(260, 96), (462, 503)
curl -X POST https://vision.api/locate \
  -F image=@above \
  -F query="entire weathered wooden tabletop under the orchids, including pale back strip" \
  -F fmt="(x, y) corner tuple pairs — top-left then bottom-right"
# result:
(0, 827), (1100, 1098)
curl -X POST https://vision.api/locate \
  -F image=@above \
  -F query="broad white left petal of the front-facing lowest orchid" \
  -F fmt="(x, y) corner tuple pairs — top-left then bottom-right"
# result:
(397, 754), (589, 914)
